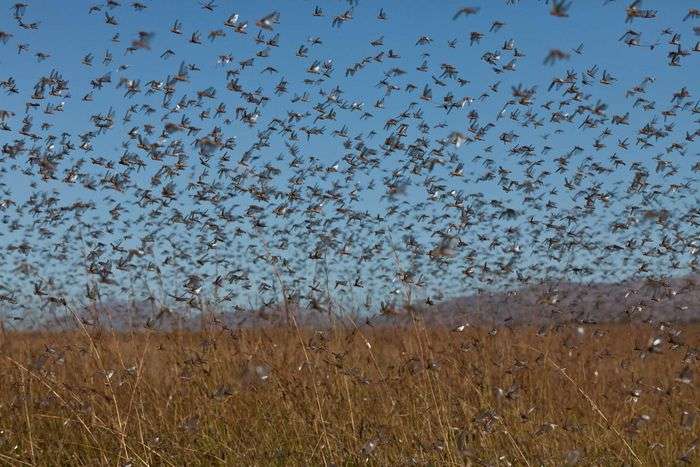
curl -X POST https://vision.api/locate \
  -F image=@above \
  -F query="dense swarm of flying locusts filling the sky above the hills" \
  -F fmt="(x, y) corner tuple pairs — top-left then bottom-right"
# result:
(0, 0), (700, 330)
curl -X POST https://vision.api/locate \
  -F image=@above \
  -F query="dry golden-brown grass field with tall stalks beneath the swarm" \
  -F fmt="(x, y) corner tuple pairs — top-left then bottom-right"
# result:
(0, 321), (700, 466)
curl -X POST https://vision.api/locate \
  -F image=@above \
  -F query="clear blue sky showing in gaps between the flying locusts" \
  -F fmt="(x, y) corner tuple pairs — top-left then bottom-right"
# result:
(0, 0), (700, 318)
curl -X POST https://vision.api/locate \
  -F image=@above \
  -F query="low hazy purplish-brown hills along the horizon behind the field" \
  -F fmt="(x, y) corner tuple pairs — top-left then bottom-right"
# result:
(32, 276), (700, 330)
